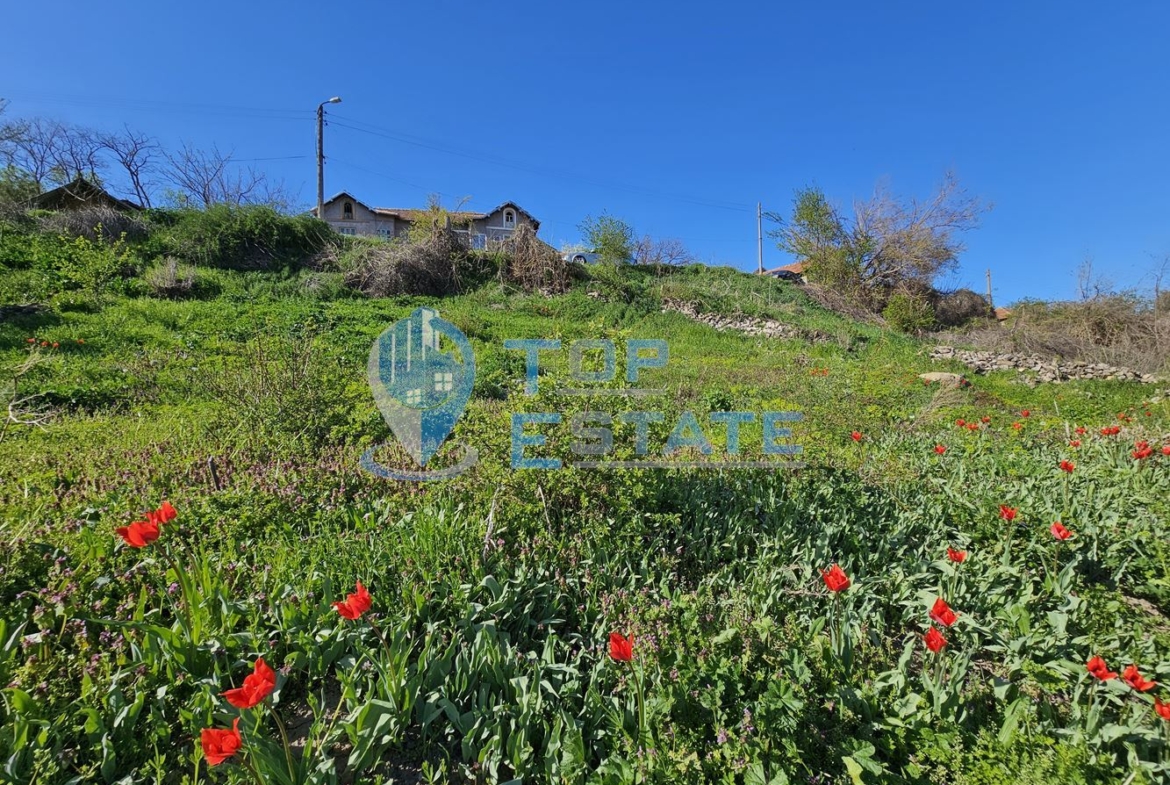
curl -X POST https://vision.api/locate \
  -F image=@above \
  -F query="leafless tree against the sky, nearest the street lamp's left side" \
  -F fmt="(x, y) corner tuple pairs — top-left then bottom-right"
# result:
(161, 144), (271, 207)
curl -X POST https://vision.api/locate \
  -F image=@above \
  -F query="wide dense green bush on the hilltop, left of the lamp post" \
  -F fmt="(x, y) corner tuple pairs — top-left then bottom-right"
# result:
(149, 205), (337, 270)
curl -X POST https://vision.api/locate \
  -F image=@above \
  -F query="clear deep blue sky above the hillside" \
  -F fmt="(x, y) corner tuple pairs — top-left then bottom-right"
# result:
(0, 0), (1170, 303)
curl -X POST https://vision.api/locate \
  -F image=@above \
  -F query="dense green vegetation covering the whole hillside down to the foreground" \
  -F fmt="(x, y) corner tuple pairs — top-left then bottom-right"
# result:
(0, 208), (1170, 785)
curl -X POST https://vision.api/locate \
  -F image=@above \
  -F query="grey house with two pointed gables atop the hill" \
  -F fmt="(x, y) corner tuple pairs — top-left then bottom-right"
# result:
(311, 191), (541, 248)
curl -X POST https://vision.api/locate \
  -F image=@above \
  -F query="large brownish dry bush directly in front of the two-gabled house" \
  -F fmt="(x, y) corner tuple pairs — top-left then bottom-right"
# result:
(339, 227), (467, 297)
